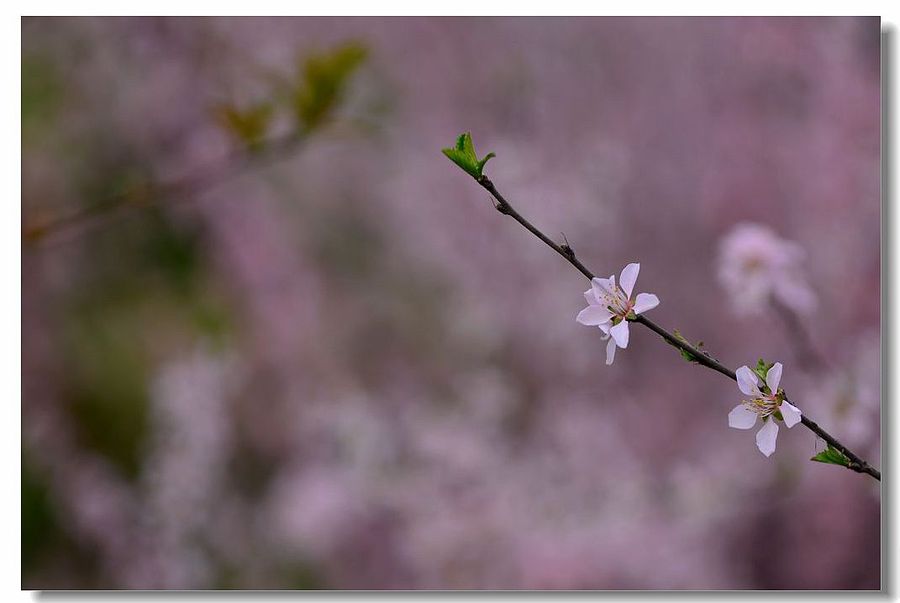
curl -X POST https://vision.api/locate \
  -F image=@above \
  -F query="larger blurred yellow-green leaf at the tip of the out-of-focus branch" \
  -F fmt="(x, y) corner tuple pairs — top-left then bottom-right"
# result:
(292, 42), (368, 132)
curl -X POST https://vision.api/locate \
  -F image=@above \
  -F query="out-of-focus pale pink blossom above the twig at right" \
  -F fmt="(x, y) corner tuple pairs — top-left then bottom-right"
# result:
(718, 223), (816, 314)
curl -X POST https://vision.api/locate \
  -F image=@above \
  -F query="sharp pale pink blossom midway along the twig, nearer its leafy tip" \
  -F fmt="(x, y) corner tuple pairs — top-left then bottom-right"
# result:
(575, 263), (659, 365)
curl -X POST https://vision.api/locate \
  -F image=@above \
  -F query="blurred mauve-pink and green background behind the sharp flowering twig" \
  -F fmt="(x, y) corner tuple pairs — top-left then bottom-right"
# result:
(22, 18), (881, 589)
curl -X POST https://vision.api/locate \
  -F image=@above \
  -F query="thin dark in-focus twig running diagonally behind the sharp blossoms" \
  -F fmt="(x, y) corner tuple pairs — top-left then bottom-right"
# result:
(475, 175), (881, 481)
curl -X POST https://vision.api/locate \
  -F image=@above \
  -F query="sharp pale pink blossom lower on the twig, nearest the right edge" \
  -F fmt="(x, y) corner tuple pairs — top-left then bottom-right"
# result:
(728, 362), (800, 456)
